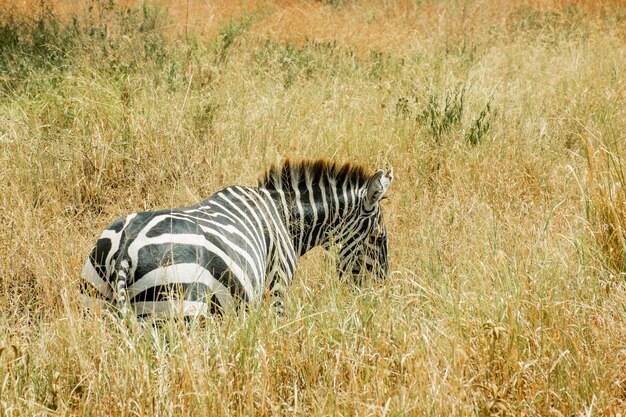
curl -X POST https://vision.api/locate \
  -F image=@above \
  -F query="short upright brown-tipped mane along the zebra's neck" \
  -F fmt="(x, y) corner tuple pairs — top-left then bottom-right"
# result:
(259, 159), (369, 190)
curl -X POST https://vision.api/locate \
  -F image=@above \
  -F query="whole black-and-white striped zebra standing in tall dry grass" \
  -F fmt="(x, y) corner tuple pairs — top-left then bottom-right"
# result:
(80, 159), (393, 318)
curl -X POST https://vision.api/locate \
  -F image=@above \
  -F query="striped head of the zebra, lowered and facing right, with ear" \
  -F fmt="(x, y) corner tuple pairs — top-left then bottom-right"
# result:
(335, 170), (393, 282)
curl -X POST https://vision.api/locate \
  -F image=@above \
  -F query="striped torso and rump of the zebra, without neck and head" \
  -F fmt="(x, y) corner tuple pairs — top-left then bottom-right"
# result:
(81, 187), (282, 315)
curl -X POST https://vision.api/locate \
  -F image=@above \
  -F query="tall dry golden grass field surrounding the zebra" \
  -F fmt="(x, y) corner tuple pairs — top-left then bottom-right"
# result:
(0, 0), (626, 416)
